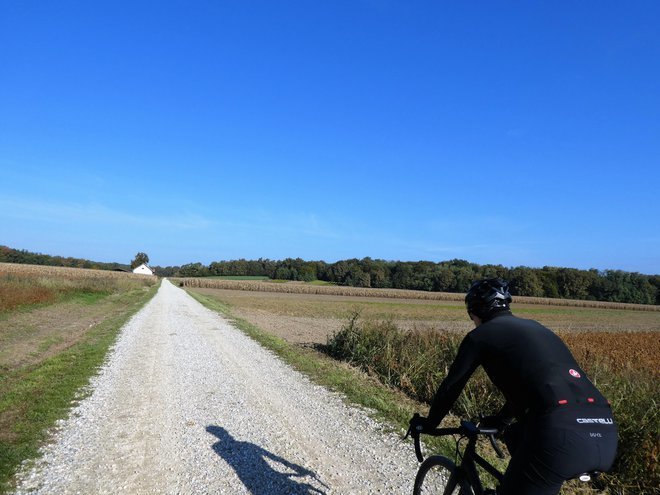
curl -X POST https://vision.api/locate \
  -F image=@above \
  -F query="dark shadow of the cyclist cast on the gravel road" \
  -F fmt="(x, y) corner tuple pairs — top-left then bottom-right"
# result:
(206, 425), (327, 495)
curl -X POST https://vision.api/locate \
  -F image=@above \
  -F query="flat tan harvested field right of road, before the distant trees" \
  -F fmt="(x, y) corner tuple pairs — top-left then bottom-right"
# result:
(184, 281), (660, 344)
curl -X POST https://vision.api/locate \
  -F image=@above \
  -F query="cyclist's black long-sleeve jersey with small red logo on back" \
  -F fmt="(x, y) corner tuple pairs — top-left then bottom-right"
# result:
(428, 311), (608, 426)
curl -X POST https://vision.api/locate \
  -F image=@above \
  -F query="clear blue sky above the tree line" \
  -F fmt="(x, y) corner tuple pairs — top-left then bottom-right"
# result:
(0, 0), (660, 274)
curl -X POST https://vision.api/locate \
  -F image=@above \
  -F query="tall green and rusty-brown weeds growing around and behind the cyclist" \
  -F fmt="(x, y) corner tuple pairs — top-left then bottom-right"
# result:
(326, 313), (660, 494)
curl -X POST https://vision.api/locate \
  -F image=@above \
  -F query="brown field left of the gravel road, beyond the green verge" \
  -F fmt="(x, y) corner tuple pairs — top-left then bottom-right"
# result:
(0, 263), (158, 370)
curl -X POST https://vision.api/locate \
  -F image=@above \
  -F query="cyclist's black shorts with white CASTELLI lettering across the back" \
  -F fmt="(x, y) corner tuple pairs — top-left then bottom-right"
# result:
(497, 407), (617, 495)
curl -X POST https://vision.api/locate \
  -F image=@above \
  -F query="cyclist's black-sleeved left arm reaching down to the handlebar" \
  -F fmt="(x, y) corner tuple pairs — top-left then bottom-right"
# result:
(427, 335), (480, 428)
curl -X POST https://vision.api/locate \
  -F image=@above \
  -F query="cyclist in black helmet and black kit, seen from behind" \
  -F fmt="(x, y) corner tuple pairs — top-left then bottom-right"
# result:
(411, 278), (617, 495)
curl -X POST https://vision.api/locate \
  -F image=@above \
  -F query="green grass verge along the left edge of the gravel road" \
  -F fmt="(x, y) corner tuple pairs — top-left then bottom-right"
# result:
(0, 285), (158, 493)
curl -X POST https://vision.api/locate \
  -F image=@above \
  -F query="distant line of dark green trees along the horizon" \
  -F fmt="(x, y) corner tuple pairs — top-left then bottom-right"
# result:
(0, 246), (660, 304)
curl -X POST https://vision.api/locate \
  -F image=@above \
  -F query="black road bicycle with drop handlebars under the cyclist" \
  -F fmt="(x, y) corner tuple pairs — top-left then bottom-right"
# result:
(404, 414), (600, 495)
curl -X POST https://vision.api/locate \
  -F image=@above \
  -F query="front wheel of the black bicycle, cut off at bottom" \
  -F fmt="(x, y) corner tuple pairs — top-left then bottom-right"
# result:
(413, 455), (472, 495)
